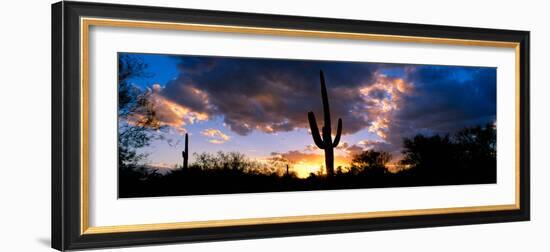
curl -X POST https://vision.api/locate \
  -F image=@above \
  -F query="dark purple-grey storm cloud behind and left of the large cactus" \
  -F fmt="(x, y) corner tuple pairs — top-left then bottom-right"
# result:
(162, 57), (377, 135)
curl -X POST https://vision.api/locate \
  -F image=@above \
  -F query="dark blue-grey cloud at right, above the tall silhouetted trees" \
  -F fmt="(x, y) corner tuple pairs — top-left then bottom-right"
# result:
(375, 66), (496, 155)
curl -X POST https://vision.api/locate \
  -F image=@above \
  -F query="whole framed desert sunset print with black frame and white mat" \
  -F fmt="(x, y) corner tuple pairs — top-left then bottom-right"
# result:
(52, 1), (530, 250)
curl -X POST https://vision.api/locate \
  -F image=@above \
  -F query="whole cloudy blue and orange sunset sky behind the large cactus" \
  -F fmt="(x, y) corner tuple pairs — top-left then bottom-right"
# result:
(119, 53), (497, 177)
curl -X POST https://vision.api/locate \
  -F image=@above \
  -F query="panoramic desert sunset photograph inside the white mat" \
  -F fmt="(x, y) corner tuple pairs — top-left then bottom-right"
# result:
(117, 52), (497, 198)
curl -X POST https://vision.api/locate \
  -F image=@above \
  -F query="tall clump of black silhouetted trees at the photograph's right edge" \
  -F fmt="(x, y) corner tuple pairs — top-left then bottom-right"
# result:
(400, 124), (496, 184)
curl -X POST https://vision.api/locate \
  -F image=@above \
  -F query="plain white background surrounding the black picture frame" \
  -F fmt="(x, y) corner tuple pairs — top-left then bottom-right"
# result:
(0, 0), (550, 251)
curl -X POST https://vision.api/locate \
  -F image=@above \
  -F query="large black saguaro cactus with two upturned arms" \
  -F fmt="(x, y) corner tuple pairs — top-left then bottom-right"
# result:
(307, 71), (342, 177)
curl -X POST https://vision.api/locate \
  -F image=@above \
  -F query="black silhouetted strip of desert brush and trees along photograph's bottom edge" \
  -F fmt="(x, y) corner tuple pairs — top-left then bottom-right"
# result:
(119, 124), (496, 197)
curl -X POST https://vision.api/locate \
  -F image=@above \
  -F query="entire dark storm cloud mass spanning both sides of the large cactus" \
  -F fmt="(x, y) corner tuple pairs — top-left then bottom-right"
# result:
(153, 56), (496, 153)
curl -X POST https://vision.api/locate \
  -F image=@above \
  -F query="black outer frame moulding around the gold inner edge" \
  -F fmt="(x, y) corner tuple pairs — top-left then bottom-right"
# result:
(51, 1), (530, 250)
